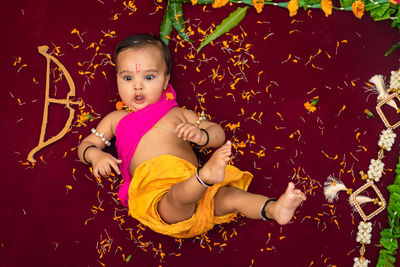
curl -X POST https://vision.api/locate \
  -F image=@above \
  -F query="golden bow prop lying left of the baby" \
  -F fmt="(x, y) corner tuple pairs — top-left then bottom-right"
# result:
(27, 45), (81, 162)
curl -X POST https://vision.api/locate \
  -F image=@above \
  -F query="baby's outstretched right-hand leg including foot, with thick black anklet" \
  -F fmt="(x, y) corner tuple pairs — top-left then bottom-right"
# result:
(215, 183), (306, 225)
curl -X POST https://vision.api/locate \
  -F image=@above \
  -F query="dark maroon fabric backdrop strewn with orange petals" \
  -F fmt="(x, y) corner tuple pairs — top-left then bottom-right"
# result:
(0, 0), (400, 266)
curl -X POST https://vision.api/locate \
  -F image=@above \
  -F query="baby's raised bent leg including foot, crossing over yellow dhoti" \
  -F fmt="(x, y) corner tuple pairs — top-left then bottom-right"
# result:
(158, 141), (231, 223)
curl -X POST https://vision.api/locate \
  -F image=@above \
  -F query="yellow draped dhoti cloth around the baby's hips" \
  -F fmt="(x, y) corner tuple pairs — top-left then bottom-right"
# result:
(129, 155), (253, 238)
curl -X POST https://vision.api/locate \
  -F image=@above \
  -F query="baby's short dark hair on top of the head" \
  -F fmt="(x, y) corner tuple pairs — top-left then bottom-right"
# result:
(114, 34), (171, 74)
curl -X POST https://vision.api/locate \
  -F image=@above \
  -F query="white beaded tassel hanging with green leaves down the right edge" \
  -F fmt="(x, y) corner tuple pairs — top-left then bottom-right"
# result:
(324, 70), (400, 267)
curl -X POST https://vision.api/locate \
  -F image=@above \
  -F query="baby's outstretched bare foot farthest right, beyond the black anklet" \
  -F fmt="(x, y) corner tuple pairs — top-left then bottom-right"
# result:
(265, 182), (306, 225)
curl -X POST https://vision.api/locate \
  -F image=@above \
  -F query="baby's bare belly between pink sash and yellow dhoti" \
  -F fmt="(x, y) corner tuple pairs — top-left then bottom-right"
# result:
(130, 133), (198, 175)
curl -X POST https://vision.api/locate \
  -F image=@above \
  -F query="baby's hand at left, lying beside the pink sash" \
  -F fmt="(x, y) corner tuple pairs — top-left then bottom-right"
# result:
(92, 151), (122, 177)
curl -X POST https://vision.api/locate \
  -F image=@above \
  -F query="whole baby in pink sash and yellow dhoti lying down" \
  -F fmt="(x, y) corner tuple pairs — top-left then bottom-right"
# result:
(78, 34), (306, 238)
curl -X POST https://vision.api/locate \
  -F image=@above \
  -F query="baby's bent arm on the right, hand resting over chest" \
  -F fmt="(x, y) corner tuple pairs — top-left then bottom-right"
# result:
(175, 109), (225, 150)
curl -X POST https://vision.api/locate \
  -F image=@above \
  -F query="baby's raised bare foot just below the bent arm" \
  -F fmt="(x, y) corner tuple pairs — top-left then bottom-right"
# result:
(199, 141), (232, 184)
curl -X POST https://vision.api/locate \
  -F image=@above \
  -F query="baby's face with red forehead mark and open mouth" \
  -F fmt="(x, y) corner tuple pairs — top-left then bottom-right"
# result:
(117, 46), (170, 111)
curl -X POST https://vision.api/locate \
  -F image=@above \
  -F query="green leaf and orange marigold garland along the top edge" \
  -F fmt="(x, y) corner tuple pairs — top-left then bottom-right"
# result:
(159, 0), (400, 56)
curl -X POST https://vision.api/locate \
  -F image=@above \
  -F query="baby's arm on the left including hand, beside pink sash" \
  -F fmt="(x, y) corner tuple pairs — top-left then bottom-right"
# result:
(78, 111), (122, 177)
